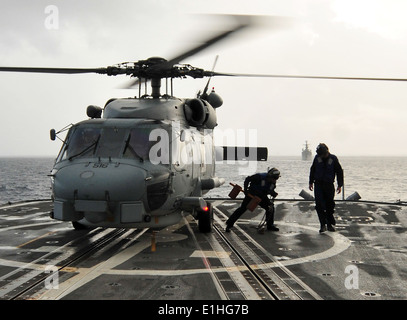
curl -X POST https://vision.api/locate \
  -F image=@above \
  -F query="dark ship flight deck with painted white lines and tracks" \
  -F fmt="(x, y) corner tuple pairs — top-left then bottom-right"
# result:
(0, 199), (407, 300)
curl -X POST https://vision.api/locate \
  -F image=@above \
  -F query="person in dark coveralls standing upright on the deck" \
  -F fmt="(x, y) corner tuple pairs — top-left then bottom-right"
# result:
(309, 143), (343, 233)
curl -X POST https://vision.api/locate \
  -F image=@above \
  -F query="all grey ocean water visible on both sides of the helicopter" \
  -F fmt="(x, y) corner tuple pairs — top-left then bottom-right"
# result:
(0, 155), (407, 204)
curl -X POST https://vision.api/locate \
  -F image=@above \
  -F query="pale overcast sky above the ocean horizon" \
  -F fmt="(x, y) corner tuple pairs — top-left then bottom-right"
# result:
(0, 0), (407, 157)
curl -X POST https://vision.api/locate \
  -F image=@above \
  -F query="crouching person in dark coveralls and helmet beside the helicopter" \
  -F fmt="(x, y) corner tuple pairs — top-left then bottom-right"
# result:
(225, 168), (280, 232)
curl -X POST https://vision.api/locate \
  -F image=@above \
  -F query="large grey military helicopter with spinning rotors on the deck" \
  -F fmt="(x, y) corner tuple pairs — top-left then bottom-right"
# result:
(0, 14), (406, 233)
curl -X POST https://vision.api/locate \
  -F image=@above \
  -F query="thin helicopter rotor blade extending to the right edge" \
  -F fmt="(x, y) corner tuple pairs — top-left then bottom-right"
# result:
(210, 71), (407, 81)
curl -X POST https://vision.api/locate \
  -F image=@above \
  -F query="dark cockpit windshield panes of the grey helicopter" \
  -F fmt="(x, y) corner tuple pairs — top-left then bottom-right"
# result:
(57, 123), (171, 161)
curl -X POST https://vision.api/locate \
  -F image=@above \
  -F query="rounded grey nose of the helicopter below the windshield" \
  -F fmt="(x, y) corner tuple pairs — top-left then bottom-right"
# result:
(54, 163), (147, 201)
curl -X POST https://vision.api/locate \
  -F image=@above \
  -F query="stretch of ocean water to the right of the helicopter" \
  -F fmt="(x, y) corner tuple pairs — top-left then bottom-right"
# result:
(208, 156), (407, 202)
